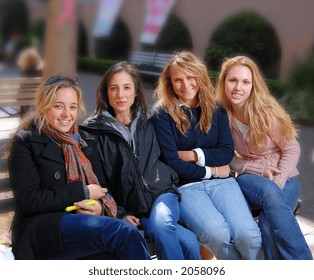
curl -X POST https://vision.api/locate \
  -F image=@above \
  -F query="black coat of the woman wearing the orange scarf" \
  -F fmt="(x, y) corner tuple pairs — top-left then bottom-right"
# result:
(8, 127), (102, 259)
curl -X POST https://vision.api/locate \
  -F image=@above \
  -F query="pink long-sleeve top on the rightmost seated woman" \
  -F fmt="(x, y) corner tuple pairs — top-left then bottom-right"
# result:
(230, 117), (301, 189)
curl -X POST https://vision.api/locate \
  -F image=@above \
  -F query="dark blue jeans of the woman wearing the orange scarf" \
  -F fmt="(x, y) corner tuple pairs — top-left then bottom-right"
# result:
(51, 214), (151, 260)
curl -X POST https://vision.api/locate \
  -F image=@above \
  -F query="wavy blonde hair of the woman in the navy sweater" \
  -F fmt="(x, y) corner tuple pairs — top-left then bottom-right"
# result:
(154, 51), (215, 135)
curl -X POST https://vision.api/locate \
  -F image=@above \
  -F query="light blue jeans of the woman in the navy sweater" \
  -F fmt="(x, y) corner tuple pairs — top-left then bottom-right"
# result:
(179, 178), (263, 260)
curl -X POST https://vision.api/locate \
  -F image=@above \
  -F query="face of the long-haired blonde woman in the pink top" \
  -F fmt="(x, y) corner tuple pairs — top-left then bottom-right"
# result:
(225, 65), (253, 109)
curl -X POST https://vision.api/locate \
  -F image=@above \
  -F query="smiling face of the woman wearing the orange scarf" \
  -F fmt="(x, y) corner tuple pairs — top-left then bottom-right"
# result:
(46, 87), (78, 133)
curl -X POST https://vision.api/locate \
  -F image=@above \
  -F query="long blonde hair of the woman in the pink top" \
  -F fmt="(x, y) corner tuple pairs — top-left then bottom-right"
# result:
(216, 56), (297, 148)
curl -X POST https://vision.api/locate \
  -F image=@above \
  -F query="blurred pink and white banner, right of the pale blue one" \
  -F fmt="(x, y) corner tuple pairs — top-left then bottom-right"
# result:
(140, 0), (175, 44)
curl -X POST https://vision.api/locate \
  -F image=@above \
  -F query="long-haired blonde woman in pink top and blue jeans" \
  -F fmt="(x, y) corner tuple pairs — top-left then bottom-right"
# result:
(216, 56), (312, 260)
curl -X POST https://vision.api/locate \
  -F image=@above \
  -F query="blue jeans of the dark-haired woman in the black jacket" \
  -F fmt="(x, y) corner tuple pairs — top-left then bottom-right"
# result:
(141, 193), (201, 260)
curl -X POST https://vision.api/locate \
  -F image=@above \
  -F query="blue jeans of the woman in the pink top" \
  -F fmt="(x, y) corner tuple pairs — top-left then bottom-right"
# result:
(237, 174), (312, 260)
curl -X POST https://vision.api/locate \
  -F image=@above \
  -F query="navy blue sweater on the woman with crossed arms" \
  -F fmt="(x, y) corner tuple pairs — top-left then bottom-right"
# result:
(150, 106), (234, 185)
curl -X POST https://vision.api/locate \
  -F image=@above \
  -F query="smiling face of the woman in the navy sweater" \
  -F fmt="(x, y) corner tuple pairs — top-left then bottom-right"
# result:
(170, 66), (200, 107)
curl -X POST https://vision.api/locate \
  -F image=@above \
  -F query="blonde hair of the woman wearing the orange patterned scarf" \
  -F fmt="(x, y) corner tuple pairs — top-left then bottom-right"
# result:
(16, 76), (86, 132)
